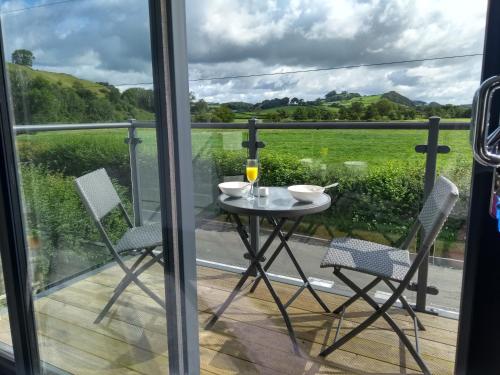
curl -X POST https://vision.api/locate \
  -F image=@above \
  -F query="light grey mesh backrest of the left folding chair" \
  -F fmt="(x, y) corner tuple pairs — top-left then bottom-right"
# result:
(75, 168), (121, 221)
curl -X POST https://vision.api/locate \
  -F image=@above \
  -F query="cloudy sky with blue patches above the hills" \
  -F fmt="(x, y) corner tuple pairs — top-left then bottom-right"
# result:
(0, 0), (486, 104)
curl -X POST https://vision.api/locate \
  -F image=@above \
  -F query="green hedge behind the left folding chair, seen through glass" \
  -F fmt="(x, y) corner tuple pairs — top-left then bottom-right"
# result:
(21, 164), (130, 287)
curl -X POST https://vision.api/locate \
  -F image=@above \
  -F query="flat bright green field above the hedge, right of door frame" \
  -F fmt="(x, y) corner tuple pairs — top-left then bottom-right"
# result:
(192, 129), (472, 170)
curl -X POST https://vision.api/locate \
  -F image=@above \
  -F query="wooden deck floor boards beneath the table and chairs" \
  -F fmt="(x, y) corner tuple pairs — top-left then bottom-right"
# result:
(0, 266), (457, 374)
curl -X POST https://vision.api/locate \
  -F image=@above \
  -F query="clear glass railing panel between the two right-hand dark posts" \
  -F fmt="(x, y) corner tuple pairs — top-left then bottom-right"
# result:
(259, 129), (427, 299)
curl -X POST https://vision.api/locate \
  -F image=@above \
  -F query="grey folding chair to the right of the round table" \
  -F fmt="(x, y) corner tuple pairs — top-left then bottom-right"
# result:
(320, 177), (458, 374)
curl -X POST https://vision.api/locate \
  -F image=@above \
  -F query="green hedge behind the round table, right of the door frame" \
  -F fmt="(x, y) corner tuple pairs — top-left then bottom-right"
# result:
(203, 151), (467, 251)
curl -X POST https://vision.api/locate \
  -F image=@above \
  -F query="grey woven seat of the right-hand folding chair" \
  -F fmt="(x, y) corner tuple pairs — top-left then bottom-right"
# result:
(321, 237), (410, 281)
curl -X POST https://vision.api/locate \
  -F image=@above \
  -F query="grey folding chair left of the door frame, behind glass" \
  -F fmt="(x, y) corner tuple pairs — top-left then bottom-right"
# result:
(75, 169), (165, 324)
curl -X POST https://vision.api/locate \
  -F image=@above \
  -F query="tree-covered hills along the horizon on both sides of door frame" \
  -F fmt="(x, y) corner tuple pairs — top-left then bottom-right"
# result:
(7, 58), (471, 125)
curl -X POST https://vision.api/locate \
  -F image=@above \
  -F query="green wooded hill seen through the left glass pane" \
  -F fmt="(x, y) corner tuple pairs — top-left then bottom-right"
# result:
(7, 63), (154, 125)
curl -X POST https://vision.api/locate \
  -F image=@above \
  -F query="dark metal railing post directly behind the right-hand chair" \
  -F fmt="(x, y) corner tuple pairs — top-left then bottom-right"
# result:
(416, 116), (441, 311)
